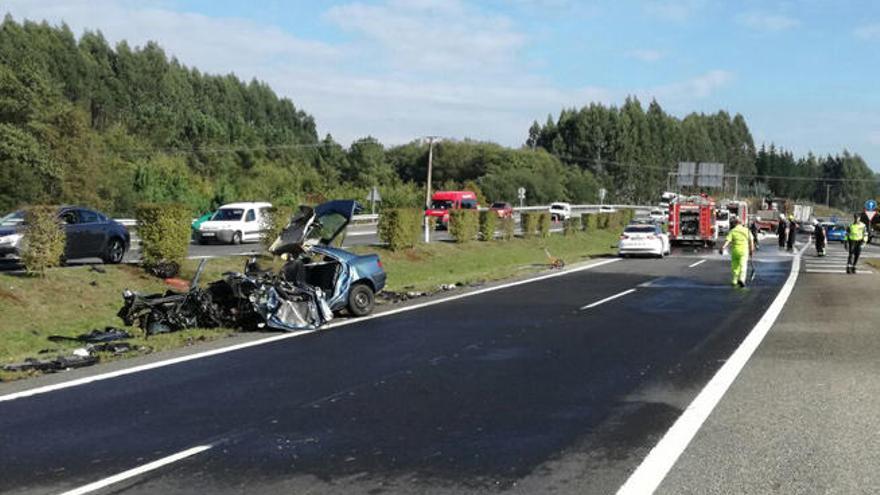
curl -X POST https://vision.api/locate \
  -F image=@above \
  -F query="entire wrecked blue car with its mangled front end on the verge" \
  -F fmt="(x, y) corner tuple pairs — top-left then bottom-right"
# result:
(118, 200), (385, 335)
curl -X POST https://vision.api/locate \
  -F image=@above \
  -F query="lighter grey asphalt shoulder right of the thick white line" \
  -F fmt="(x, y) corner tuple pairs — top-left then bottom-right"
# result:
(657, 243), (880, 495)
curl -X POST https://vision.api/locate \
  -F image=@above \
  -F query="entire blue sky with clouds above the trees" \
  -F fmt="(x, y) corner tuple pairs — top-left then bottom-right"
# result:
(0, 0), (880, 170)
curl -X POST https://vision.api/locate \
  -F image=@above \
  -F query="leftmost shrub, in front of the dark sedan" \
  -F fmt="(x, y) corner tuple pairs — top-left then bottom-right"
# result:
(21, 206), (66, 275)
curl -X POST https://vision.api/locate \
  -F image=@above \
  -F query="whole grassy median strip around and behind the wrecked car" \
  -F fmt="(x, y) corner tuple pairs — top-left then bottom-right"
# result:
(0, 231), (617, 380)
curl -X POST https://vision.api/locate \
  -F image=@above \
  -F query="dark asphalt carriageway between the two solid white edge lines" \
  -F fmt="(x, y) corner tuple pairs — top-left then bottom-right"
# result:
(0, 252), (791, 494)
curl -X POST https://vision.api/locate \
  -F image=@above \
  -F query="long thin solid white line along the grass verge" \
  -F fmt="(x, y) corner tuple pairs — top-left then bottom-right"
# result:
(0, 258), (620, 402)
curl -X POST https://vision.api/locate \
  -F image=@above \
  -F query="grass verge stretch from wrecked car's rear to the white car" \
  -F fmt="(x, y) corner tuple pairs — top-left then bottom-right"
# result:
(355, 231), (617, 291)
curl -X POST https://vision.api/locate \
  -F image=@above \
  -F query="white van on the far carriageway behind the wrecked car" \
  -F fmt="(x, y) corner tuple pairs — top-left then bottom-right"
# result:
(196, 203), (272, 244)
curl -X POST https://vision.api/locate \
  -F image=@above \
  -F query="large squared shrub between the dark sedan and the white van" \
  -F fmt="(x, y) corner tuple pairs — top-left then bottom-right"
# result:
(135, 203), (192, 276)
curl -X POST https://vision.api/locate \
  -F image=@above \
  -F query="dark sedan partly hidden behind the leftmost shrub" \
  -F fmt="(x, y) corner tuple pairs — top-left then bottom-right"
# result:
(0, 206), (131, 264)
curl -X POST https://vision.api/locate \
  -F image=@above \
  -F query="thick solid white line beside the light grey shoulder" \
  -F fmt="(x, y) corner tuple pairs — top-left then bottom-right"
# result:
(617, 242), (804, 495)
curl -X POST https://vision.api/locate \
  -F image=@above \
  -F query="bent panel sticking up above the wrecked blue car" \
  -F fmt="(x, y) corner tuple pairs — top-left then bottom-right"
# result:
(269, 200), (362, 256)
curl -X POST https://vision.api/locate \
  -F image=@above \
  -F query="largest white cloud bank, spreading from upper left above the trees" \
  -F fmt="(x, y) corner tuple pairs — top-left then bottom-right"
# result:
(4, 0), (732, 146)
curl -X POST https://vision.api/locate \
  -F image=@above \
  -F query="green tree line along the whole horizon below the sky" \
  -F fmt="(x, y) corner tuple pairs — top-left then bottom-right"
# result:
(0, 15), (875, 215)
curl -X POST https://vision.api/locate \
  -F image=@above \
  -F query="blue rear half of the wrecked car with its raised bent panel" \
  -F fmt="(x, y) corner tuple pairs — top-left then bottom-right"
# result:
(269, 200), (386, 316)
